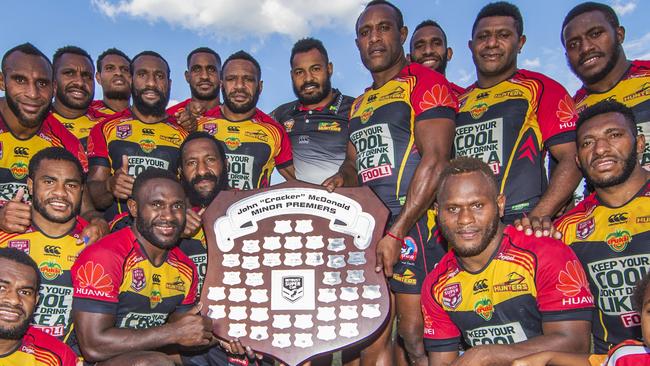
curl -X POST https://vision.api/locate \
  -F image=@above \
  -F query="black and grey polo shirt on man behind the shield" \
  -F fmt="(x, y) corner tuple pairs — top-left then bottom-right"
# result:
(271, 89), (354, 184)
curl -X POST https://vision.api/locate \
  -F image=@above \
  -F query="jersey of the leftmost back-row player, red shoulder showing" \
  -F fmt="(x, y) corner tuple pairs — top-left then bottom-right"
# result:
(0, 115), (88, 205)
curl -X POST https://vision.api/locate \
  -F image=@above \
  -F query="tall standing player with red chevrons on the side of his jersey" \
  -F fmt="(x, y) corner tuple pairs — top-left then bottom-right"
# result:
(454, 2), (580, 233)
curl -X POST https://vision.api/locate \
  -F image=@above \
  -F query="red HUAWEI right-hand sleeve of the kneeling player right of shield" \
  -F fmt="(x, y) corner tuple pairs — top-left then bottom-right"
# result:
(522, 234), (594, 321)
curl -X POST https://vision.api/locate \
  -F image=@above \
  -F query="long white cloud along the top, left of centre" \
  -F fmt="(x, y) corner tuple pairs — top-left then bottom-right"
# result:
(92, 0), (367, 40)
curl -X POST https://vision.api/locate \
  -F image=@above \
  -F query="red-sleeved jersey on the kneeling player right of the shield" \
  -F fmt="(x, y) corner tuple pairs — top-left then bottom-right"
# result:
(421, 226), (593, 352)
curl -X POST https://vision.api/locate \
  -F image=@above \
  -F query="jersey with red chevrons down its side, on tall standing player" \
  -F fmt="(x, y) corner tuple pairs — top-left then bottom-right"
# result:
(454, 70), (577, 216)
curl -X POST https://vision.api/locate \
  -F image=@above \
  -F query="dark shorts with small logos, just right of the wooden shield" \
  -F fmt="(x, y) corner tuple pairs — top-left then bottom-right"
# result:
(389, 211), (447, 294)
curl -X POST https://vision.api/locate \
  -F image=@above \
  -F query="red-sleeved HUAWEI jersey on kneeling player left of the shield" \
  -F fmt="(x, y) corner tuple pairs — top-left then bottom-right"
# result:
(72, 228), (198, 329)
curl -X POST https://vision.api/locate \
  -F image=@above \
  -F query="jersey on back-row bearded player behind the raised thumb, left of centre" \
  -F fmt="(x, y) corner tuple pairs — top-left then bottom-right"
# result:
(88, 111), (187, 220)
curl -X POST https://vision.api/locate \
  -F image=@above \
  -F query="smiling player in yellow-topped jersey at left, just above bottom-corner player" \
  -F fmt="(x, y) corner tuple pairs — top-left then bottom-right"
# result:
(0, 147), (86, 342)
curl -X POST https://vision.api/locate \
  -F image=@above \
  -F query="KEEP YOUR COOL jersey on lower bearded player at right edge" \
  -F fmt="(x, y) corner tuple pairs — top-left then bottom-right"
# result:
(555, 181), (650, 353)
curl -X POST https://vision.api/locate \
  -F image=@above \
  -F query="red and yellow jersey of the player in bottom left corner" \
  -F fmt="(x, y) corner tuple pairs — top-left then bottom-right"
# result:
(0, 327), (77, 366)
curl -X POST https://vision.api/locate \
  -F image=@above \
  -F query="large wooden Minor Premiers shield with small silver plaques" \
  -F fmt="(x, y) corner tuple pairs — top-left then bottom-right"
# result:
(201, 182), (390, 365)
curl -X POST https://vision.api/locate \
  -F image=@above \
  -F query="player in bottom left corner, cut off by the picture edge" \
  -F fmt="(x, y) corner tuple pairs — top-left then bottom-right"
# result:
(0, 248), (77, 366)
